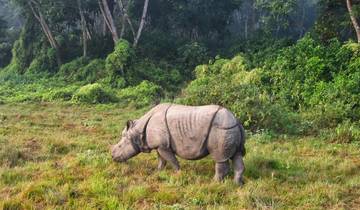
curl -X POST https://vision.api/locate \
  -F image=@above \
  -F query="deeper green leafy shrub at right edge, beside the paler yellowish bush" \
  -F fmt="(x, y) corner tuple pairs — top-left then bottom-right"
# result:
(264, 35), (360, 111)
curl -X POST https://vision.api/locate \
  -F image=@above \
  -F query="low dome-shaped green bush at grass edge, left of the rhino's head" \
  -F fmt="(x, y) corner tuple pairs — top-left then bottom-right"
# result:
(71, 83), (117, 104)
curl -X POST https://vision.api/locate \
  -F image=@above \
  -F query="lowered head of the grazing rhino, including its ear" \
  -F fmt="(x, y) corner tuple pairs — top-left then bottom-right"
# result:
(112, 120), (141, 162)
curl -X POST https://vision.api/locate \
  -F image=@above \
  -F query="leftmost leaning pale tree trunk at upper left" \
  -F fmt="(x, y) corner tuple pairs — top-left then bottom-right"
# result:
(28, 0), (62, 66)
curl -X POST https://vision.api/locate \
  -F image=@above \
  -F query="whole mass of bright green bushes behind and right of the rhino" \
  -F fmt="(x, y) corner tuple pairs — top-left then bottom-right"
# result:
(180, 36), (360, 139)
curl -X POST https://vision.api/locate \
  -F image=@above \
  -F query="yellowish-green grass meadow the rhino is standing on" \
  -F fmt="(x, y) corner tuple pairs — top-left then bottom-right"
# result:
(0, 103), (360, 209)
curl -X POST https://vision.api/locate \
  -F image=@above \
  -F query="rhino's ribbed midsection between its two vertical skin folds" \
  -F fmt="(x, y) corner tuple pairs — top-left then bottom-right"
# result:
(166, 105), (219, 159)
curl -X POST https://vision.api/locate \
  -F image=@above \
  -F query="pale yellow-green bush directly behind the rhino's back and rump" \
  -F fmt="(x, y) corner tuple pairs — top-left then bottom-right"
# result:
(180, 56), (298, 133)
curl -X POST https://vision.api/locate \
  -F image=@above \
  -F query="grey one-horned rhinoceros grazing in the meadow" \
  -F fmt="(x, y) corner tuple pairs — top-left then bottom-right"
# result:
(112, 104), (245, 185)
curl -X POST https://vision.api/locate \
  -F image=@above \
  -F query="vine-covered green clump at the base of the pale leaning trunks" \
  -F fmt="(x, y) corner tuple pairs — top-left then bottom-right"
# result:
(106, 39), (134, 75)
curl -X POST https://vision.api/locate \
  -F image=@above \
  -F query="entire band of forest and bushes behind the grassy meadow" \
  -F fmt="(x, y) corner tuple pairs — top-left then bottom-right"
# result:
(0, 0), (360, 138)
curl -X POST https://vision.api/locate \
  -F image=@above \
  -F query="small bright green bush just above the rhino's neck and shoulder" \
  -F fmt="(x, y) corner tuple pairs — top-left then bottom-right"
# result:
(118, 81), (161, 108)
